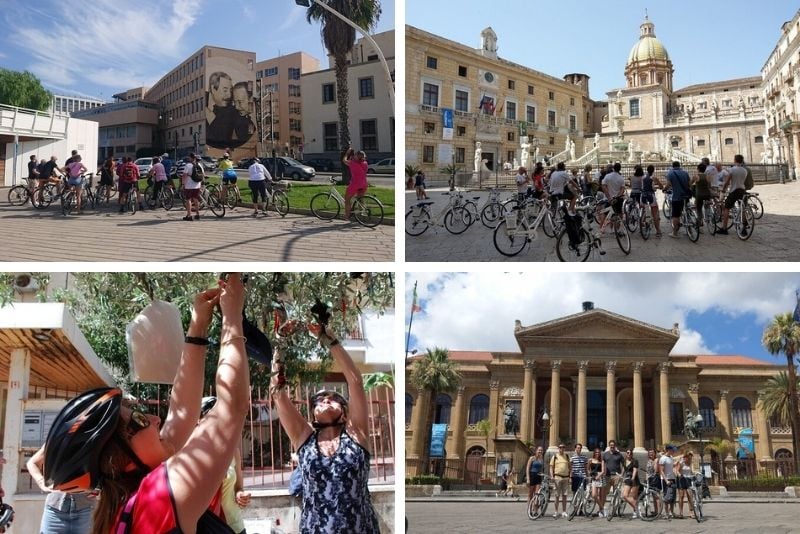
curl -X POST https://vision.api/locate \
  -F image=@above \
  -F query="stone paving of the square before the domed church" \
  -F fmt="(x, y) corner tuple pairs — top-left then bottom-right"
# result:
(410, 182), (800, 262)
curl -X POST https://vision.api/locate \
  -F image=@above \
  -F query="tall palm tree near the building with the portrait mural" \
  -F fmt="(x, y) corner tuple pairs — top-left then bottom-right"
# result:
(306, 0), (381, 150)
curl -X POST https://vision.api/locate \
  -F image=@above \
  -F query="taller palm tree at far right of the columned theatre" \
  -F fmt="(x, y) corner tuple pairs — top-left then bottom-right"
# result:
(761, 312), (800, 473)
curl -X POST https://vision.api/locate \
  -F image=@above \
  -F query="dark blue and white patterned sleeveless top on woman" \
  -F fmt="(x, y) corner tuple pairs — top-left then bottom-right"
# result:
(297, 430), (380, 534)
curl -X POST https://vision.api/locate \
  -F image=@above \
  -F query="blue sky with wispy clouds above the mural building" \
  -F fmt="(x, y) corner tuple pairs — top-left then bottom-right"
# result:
(0, 0), (395, 100)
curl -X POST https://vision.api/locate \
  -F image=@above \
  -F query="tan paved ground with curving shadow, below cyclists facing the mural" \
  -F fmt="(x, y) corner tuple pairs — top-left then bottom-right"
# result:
(0, 200), (394, 261)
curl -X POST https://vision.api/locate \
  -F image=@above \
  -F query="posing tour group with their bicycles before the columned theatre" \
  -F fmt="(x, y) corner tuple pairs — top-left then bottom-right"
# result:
(520, 440), (709, 522)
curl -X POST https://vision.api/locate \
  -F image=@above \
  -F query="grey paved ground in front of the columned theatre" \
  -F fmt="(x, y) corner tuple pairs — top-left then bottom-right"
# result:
(406, 500), (800, 534)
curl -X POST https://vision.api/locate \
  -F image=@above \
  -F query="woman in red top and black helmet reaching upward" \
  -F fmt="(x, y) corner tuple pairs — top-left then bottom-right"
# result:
(44, 274), (250, 534)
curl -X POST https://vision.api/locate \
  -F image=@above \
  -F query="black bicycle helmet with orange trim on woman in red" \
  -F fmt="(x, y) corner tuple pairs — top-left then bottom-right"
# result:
(44, 388), (122, 493)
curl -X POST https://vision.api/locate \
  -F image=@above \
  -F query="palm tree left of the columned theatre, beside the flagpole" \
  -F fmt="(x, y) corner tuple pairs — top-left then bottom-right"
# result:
(411, 347), (461, 474)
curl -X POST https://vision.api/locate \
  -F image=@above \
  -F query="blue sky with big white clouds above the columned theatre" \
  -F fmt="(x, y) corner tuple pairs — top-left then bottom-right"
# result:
(405, 272), (800, 364)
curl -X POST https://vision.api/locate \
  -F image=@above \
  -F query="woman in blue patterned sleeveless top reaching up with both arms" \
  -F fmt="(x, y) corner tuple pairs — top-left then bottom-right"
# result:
(270, 325), (380, 534)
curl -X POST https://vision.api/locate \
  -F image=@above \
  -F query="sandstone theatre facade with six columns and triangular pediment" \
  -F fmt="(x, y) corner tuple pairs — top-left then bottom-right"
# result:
(406, 302), (792, 482)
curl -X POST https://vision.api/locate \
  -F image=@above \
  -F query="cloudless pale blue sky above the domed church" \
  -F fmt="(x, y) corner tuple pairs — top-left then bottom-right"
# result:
(406, 0), (798, 100)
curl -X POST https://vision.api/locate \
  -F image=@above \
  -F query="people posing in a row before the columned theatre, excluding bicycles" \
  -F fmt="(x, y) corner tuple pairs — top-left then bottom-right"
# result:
(524, 440), (696, 519)
